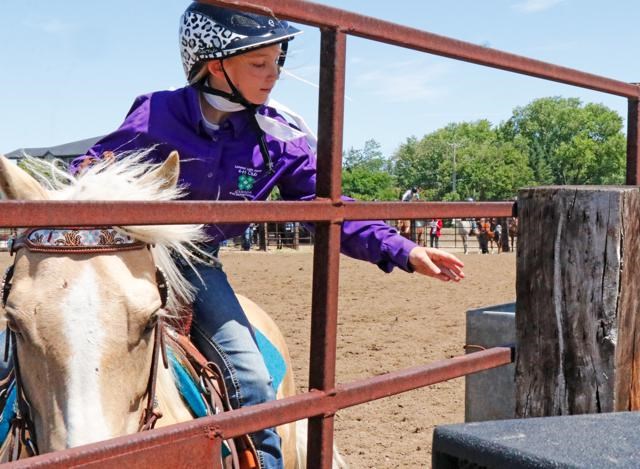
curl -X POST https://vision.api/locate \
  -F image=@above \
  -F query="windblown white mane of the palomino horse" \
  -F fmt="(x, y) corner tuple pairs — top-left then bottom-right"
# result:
(23, 150), (206, 314)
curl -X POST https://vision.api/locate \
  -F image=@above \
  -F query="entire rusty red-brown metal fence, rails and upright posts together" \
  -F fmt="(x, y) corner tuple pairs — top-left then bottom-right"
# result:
(0, 0), (640, 468)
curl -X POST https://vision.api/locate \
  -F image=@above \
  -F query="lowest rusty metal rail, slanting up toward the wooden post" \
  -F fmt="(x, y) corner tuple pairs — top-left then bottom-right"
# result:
(4, 347), (513, 468)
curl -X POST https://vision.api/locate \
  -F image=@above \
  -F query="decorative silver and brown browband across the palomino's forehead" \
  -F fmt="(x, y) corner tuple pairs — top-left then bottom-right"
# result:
(10, 228), (146, 254)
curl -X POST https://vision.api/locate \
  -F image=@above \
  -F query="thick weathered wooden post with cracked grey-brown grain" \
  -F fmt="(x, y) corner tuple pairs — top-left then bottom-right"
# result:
(516, 186), (640, 417)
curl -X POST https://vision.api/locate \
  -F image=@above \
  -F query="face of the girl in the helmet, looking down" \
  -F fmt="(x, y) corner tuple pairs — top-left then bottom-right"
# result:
(210, 44), (281, 104)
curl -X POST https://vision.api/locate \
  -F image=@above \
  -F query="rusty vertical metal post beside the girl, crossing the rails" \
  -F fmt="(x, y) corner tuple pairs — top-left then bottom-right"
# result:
(307, 29), (346, 469)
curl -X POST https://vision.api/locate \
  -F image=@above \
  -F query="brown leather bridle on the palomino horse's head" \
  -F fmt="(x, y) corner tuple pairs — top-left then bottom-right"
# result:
(0, 227), (169, 460)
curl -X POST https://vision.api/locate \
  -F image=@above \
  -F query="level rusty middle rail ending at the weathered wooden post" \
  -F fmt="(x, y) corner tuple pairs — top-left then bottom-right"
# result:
(0, 199), (514, 228)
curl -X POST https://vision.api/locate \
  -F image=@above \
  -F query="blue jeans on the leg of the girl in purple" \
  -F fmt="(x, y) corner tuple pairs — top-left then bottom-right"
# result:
(183, 254), (283, 469)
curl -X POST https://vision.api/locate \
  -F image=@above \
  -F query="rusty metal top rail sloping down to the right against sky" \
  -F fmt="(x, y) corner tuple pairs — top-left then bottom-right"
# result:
(211, 0), (640, 99)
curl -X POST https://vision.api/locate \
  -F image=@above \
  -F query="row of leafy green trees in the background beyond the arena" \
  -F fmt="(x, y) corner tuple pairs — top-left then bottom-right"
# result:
(343, 97), (626, 201)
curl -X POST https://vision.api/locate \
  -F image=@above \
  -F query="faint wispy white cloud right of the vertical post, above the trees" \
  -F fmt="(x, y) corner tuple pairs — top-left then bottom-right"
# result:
(353, 59), (450, 103)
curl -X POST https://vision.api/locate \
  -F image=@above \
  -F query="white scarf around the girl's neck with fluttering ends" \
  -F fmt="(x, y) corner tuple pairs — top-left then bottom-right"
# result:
(202, 89), (318, 153)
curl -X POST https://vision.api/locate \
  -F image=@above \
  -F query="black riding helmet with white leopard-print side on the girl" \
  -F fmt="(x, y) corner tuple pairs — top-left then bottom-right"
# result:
(180, 2), (302, 82)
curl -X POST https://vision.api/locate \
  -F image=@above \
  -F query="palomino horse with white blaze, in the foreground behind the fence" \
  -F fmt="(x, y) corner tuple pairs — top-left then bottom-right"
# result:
(0, 152), (339, 468)
